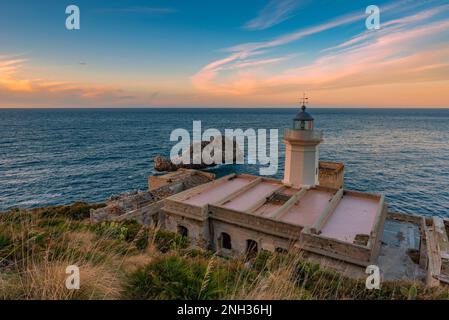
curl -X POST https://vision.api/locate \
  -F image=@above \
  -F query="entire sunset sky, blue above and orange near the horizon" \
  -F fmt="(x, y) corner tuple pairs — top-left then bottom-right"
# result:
(0, 0), (449, 108)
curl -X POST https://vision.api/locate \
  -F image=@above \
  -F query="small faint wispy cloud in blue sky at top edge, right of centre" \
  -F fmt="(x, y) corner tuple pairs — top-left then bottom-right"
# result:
(243, 0), (300, 30)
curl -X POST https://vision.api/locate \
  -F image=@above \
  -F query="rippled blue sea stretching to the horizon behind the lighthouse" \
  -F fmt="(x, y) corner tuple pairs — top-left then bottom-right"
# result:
(0, 108), (449, 217)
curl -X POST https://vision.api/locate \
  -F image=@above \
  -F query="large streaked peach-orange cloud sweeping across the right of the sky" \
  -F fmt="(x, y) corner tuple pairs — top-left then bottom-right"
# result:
(192, 1), (449, 105)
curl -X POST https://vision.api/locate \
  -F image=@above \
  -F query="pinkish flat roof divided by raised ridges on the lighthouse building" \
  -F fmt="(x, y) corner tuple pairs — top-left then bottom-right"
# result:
(172, 174), (383, 243)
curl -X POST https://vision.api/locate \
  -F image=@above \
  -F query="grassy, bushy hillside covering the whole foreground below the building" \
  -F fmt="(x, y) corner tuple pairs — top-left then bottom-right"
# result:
(0, 203), (449, 299)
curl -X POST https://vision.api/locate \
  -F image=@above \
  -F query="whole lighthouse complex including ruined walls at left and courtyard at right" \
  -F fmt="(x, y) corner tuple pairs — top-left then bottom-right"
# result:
(91, 102), (449, 286)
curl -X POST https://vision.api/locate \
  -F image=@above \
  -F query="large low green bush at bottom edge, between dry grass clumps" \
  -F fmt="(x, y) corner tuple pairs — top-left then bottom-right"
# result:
(125, 252), (257, 300)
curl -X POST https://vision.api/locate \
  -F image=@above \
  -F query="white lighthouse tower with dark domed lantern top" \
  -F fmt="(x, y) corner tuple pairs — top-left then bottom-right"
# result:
(284, 96), (322, 188)
